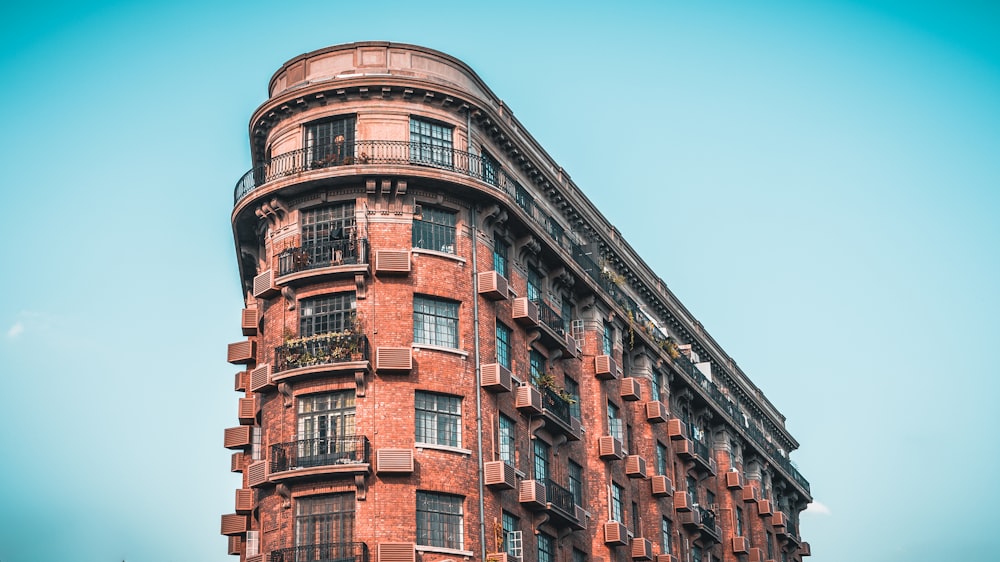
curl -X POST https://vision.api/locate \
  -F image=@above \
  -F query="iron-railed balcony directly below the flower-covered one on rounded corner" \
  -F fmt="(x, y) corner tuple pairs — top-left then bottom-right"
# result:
(269, 435), (370, 482)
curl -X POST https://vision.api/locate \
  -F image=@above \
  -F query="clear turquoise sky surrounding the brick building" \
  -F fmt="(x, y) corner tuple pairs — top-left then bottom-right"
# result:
(0, 0), (1000, 562)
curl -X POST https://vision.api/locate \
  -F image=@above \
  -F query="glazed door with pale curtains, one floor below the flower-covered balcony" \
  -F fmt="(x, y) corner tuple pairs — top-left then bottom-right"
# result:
(297, 390), (361, 467)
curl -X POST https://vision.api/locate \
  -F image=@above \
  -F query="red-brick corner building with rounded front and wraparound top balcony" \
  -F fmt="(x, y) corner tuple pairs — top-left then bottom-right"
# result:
(222, 42), (810, 562)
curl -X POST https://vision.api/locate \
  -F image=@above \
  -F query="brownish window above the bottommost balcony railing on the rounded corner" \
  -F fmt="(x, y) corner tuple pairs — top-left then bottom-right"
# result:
(295, 492), (355, 548)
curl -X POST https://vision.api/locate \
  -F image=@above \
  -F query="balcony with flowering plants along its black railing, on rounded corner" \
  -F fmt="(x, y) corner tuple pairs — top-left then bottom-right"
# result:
(273, 332), (369, 376)
